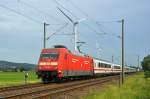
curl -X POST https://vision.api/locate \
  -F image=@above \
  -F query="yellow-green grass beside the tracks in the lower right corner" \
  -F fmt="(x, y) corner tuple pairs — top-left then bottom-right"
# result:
(82, 73), (150, 99)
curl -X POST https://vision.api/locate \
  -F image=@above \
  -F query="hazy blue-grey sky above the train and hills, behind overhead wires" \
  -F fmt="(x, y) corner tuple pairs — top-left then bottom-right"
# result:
(0, 0), (150, 65)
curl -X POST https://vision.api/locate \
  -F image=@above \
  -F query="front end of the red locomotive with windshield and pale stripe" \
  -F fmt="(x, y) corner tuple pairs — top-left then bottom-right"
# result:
(37, 49), (59, 83)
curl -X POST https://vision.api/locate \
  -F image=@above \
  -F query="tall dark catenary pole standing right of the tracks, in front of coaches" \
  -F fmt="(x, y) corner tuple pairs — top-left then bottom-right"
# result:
(121, 19), (124, 84)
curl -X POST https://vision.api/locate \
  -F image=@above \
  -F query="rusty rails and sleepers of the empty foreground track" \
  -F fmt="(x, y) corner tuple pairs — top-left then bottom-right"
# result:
(0, 75), (119, 99)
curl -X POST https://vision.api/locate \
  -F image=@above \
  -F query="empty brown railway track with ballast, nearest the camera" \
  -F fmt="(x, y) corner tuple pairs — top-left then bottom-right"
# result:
(0, 76), (119, 99)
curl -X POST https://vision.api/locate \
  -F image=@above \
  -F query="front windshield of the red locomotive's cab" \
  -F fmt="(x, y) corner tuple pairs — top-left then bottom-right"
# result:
(40, 52), (59, 59)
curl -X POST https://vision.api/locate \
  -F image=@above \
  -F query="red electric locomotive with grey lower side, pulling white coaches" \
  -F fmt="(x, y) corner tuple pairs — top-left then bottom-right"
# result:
(37, 46), (94, 83)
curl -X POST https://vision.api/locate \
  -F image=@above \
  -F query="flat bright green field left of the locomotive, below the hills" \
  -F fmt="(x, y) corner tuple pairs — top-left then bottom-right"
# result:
(0, 72), (40, 87)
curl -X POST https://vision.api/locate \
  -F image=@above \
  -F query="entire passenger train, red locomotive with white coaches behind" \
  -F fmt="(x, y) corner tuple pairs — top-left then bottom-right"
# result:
(36, 46), (136, 83)
